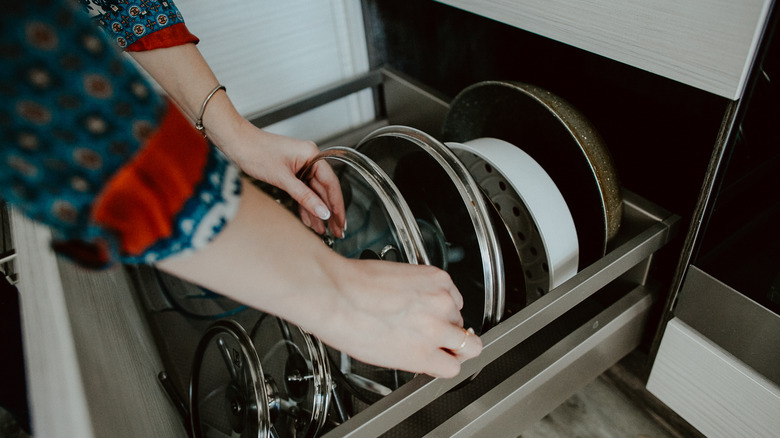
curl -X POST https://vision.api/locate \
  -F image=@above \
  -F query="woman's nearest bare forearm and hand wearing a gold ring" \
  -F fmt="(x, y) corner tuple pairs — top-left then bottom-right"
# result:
(158, 180), (482, 377)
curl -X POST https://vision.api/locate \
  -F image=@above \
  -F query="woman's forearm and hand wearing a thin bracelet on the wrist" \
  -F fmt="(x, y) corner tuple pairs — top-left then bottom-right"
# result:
(128, 43), (345, 236)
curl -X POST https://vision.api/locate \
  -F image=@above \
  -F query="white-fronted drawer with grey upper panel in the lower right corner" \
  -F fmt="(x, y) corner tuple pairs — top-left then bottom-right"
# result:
(647, 266), (780, 438)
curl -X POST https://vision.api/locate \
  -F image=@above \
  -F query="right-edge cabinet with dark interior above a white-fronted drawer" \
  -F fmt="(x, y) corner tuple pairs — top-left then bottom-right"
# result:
(647, 3), (780, 437)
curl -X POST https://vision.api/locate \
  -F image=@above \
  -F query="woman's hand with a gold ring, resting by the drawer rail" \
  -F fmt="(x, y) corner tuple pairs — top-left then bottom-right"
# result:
(311, 260), (482, 378)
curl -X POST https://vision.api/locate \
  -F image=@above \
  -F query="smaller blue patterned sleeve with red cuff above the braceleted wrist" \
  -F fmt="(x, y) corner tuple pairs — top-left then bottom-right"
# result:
(79, 0), (198, 52)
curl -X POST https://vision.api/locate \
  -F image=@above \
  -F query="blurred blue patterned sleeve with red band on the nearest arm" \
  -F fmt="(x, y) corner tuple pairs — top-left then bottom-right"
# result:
(0, 0), (241, 268)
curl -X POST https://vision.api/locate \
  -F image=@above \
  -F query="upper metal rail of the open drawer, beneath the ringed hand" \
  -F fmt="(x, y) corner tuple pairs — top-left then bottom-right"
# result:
(325, 192), (679, 438)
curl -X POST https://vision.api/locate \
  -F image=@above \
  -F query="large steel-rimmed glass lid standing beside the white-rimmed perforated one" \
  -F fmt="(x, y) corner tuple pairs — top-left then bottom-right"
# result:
(356, 126), (505, 333)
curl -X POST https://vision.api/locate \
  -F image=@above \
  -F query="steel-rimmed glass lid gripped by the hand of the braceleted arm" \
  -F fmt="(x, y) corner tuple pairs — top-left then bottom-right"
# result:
(301, 147), (430, 264)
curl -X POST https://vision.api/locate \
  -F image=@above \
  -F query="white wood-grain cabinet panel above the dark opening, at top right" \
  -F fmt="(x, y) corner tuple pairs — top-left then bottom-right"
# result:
(439, 0), (771, 99)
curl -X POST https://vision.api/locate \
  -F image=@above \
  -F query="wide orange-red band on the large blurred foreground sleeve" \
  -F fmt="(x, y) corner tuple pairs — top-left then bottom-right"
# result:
(93, 101), (209, 255)
